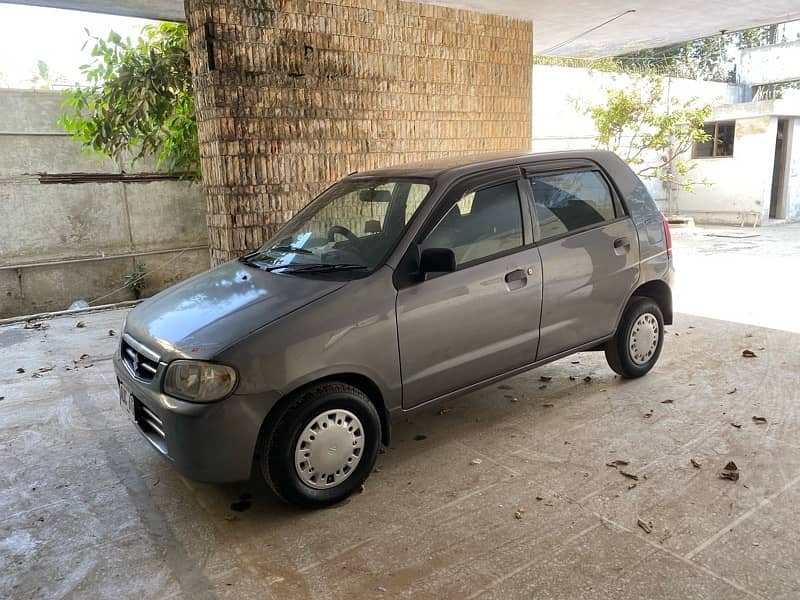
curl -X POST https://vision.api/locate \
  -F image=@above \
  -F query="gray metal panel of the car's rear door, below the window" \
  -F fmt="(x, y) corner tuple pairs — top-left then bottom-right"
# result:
(537, 218), (639, 360)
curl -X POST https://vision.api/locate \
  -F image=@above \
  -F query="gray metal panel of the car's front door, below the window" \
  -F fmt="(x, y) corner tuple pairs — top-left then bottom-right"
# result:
(397, 248), (542, 409)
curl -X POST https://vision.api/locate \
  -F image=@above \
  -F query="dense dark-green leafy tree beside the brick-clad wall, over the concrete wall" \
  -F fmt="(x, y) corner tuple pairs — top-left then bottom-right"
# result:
(59, 23), (200, 179)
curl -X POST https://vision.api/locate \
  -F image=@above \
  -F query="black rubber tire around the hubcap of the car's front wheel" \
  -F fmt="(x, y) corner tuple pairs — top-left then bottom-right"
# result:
(258, 381), (381, 508)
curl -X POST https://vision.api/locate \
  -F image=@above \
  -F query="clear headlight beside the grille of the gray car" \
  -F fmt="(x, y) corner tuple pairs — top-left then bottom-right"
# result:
(164, 360), (236, 402)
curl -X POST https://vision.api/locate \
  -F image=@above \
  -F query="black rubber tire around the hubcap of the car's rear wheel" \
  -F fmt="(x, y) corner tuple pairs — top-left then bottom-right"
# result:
(605, 296), (664, 379)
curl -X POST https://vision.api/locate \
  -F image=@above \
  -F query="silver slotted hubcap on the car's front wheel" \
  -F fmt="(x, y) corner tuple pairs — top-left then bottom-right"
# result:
(294, 410), (364, 490)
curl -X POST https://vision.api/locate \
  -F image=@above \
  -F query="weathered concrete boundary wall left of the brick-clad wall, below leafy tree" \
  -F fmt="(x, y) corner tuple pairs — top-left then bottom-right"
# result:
(0, 90), (209, 318)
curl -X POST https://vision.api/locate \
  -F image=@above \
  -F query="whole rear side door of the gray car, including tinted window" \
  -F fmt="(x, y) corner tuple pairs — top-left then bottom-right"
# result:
(525, 162), (639, 359)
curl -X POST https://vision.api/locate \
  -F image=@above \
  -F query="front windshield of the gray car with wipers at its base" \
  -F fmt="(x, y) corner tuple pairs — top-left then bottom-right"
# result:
(240, 179), (430, 273)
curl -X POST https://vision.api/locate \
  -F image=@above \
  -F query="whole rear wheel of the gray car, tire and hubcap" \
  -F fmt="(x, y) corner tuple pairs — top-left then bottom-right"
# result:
(605, 297), (664, 378)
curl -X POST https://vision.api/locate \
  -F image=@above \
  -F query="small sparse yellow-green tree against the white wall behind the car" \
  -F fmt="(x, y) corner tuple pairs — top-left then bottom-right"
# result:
(578, 77), (711, 191)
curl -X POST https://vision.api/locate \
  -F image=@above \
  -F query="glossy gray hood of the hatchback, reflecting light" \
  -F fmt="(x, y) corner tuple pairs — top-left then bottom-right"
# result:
(125, 261), (347, 361)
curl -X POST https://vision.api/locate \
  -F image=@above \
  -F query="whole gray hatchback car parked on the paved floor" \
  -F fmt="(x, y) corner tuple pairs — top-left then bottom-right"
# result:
(114, 151), (673, 507)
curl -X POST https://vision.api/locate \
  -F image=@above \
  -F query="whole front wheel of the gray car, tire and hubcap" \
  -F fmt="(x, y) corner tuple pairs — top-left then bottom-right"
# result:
(259, 382), (381, 508)
